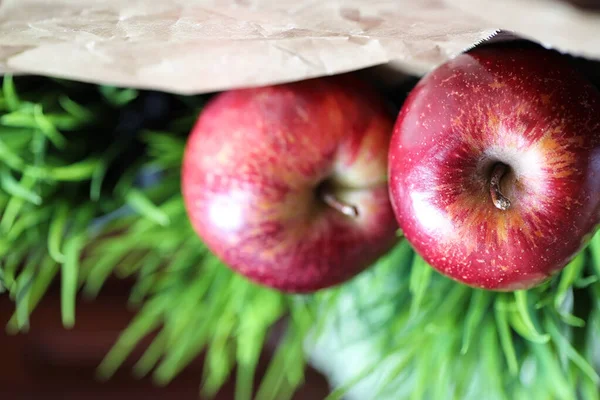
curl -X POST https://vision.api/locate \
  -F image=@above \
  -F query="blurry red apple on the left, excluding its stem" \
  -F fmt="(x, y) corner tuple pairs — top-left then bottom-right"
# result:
(182, 76), (398, 293)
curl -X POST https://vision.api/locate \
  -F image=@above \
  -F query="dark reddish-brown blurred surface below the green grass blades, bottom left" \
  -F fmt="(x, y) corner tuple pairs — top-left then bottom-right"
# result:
(0, 280), (328, 400)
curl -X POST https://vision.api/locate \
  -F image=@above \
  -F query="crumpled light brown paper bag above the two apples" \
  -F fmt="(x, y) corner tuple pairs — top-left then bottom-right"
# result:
(0, 0), (600, 94)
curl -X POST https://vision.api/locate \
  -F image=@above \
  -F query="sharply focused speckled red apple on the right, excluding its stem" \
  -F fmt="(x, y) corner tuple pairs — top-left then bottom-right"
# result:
(389, 48), (600, 291)
